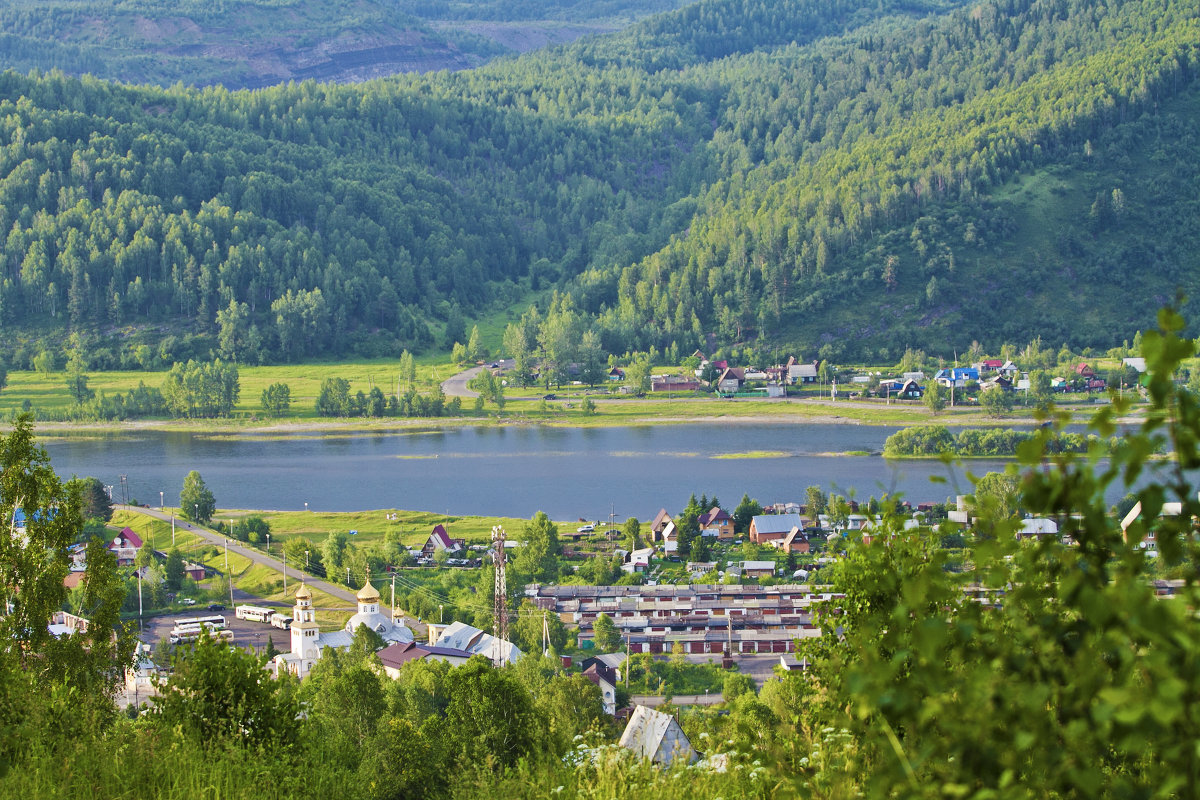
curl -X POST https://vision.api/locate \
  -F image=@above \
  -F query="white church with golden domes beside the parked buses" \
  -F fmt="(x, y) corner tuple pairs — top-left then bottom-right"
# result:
(271, 581), (413, 679)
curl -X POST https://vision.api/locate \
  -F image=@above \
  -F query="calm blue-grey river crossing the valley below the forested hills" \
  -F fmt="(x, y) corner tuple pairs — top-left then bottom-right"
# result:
(42, 422), (1099, 519)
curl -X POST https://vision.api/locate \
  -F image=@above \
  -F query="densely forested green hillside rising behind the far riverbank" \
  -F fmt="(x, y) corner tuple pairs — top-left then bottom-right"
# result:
(0, 0), (1200, 361)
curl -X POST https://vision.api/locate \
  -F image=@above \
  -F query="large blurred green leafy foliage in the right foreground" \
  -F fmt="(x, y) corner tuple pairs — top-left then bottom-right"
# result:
(809, 311), (1200, 796)
